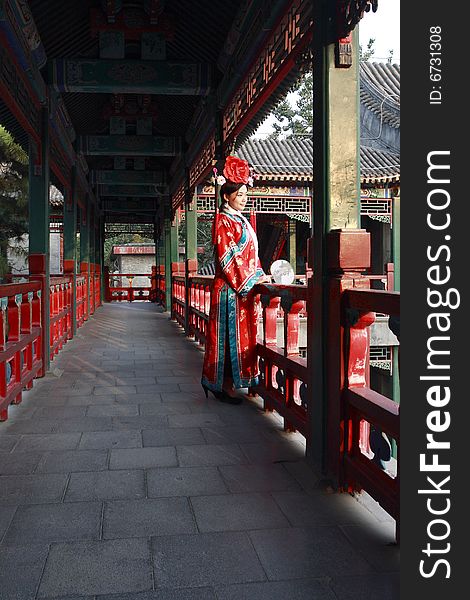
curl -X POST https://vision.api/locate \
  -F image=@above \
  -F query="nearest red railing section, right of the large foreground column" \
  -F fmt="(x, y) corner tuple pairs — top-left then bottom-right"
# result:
(340, 289), (400, 521)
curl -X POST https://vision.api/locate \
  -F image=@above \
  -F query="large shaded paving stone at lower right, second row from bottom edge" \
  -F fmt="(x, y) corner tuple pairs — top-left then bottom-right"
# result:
(250, 526), (372, 581)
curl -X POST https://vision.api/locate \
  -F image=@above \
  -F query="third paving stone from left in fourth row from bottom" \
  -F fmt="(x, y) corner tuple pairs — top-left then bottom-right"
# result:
(147, 467), (227, 498)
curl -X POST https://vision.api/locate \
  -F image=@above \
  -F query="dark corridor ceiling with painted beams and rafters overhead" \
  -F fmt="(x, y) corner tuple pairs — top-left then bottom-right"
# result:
(0, 0), (320, 222)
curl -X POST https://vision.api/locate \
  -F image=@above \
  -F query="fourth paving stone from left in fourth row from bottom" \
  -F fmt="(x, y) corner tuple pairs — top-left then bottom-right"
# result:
(219, 465), (300, 493)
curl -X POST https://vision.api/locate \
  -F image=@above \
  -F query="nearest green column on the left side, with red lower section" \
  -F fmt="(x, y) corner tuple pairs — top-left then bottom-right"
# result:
(29, 108), (50, 376)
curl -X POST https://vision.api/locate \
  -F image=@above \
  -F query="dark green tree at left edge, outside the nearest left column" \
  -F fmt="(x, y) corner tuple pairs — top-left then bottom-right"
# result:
(0, 125), (28, 277)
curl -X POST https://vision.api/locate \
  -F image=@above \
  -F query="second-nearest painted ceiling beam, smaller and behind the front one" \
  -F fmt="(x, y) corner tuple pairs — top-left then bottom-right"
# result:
(78, 135), (181, 156)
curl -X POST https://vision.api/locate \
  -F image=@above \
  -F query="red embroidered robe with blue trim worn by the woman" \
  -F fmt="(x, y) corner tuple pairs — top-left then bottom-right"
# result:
(201, 211), (264, 391)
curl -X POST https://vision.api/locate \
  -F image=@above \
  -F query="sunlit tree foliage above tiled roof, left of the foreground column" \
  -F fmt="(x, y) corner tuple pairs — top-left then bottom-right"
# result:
(269, 72), (313, 139)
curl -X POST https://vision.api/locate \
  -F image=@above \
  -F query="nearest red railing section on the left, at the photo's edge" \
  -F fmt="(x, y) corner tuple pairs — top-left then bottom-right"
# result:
(0, 282), (43, 421)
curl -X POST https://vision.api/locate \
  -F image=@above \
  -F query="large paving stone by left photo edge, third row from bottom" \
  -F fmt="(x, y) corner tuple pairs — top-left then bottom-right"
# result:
(3, 502), (101, 546)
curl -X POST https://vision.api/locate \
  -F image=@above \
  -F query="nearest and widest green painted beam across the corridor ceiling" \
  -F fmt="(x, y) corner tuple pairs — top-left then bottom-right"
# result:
(49, 58), (211, 96)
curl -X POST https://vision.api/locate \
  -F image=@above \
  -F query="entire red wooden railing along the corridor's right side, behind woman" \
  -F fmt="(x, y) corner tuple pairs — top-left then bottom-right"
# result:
(171, 265), (400, 521)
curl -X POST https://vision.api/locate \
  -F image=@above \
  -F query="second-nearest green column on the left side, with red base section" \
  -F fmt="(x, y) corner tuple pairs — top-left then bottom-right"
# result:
(63, 167), (77, 335)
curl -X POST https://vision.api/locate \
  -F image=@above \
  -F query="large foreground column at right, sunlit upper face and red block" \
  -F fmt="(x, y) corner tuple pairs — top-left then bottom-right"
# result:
(307, 17), (364, 480)
